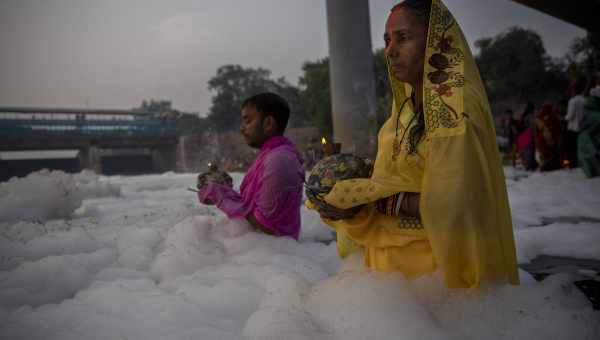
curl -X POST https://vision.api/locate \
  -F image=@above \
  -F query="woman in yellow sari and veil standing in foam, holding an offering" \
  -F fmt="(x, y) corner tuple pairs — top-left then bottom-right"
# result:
(318, 0), (519, 287)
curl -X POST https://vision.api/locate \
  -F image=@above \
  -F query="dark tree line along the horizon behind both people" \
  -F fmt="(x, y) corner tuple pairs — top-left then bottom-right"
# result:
(138, 27), (600, 135)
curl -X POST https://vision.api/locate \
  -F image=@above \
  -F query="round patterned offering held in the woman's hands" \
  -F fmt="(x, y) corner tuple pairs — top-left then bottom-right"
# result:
(305, 153), (373, 206)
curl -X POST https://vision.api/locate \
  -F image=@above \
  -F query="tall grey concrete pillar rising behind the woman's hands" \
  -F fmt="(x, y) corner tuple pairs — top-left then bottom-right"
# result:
(327, 0), (377, 157)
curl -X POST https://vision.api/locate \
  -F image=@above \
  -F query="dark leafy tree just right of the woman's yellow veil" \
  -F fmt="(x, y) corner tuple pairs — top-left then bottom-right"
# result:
(475, 27), (566, 113)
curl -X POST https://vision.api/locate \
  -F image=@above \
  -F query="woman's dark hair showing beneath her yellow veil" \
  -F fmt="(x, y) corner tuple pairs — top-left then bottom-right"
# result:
(391, 0), (431, 155)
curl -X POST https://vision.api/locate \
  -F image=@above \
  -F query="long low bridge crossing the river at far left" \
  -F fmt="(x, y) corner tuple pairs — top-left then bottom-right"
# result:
(0, 107), (178, 181)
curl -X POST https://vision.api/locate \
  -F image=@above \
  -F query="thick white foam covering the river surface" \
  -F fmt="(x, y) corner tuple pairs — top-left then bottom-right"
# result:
(0, 170), (600, 340)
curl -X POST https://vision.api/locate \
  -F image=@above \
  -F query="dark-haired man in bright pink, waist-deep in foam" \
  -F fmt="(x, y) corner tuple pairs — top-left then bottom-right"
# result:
(198, 93), (304, 239)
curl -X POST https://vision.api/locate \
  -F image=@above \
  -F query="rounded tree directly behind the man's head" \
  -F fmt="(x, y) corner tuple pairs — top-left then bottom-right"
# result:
(208, 65), (307, 131)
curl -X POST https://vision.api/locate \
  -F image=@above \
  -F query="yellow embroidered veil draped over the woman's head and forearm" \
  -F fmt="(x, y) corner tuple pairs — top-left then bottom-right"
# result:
(325, 0), (519, 287)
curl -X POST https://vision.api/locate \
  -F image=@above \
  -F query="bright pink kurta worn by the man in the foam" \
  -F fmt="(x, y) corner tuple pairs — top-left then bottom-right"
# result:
(198, 136), (304, 239)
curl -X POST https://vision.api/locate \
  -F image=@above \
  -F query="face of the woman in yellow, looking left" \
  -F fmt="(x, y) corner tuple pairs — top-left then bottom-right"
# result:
(383, 8), (427, 85)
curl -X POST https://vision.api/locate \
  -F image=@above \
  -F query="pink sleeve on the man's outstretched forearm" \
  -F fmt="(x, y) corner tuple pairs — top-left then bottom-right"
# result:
(198, 183), (253, 218)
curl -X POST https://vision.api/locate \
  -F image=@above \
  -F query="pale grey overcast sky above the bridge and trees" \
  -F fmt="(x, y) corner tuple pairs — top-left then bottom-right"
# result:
(0, 0), (585, 114)
